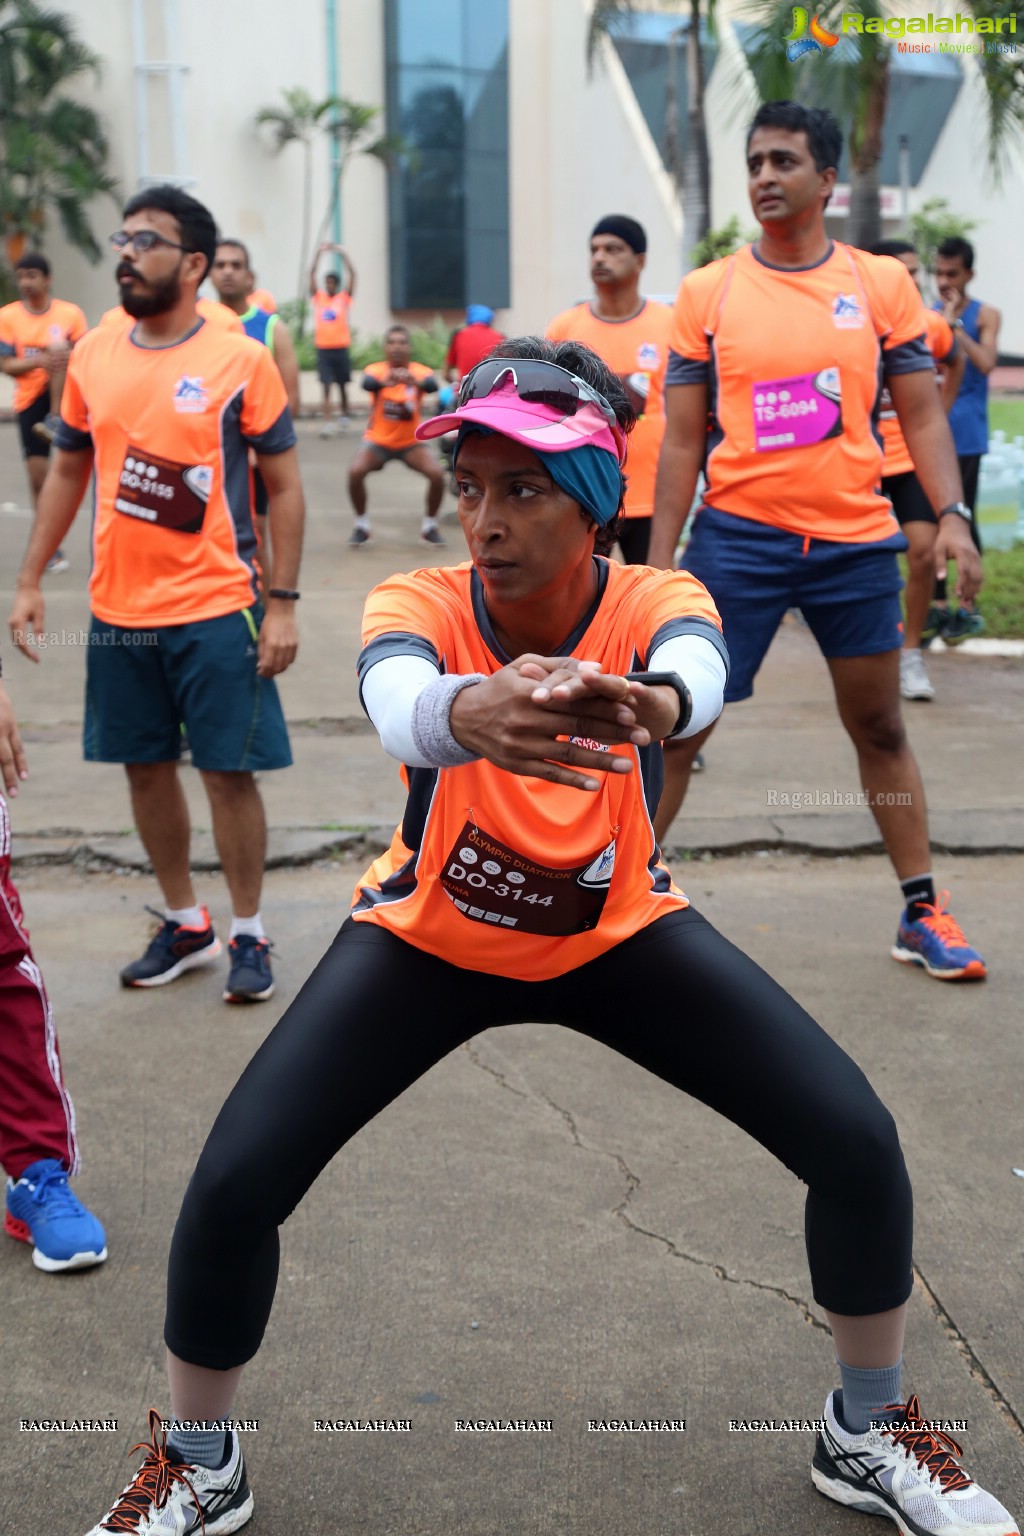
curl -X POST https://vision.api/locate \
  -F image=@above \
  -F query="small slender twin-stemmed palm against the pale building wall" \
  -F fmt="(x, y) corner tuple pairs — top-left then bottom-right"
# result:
(256, 86), (405, 333)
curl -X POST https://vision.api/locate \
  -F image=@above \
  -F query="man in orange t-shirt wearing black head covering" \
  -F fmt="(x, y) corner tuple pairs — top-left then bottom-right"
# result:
(547, 214), (672, 565)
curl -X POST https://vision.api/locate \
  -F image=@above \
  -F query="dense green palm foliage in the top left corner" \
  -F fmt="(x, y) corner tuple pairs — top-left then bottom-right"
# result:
(0, 0), (117, 282)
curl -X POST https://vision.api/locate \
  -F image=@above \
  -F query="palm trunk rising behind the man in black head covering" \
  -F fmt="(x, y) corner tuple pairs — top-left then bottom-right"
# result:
(586, 0), (715, 270)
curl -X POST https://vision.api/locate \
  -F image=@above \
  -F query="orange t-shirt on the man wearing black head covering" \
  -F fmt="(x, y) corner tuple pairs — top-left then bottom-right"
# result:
(547, 300), (672, 518)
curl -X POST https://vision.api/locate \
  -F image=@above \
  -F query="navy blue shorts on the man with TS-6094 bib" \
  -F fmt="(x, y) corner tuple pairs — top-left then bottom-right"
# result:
(680, 507), (907, 703)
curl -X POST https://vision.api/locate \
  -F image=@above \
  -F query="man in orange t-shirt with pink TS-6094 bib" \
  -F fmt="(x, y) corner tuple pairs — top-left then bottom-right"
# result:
(651, 101), (986, 982)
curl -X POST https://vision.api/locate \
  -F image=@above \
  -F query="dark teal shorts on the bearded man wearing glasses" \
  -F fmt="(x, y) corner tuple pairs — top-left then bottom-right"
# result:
(84, 605), (292, 773)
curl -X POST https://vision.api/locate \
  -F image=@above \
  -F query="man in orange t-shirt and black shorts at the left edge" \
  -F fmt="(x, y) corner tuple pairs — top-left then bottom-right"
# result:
(0, 250), (88, 573)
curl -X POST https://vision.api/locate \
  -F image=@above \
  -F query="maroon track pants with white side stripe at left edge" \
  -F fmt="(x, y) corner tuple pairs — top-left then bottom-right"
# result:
(0, 794), (78, 1178)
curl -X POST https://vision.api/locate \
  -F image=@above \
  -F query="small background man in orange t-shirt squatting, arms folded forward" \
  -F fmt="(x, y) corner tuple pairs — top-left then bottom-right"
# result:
(348, 326), (444, 550)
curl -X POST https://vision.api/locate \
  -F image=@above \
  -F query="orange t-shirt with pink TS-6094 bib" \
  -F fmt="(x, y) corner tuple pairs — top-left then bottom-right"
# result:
(666, 243), (933, 544)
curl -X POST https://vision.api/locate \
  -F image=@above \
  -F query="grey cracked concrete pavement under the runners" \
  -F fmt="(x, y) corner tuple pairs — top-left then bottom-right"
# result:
(0, 425), (1024, 1536)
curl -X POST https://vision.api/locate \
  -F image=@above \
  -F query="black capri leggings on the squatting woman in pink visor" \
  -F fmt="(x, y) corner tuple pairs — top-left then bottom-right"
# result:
(164, 906), (912, 1370)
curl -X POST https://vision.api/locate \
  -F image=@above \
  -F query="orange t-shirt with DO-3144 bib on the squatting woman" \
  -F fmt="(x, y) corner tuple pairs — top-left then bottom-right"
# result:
(352, 559), (722, 982)
